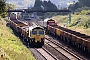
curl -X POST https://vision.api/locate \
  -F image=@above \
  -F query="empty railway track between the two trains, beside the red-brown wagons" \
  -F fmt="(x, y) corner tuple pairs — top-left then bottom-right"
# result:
(45, 36), (87, 60)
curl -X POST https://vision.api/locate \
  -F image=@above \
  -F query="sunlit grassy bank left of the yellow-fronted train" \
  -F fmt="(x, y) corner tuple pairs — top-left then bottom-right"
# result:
(0, 18), (35, 60)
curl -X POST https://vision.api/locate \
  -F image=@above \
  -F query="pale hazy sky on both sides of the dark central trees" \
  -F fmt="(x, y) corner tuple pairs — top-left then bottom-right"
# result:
(7, 0), (78, 8)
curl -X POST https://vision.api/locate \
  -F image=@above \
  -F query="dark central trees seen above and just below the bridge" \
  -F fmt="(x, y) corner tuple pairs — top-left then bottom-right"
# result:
(32, 0), (57, 17)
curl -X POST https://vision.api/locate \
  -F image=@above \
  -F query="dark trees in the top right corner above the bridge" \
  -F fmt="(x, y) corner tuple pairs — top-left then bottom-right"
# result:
(69, 0), (90, 12)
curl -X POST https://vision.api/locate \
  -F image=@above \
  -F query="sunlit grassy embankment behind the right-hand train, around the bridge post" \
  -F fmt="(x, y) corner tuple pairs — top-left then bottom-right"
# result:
(53, 14), (90, 36)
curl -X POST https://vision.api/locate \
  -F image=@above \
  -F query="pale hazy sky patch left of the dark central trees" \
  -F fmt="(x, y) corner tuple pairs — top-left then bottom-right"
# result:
(7, 0), (35, 8)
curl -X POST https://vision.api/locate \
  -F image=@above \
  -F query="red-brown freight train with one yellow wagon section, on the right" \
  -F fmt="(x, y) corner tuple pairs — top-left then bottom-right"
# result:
(44, 19), (90, 53)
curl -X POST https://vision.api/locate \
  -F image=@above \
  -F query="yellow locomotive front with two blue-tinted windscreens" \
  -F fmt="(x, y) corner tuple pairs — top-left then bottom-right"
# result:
(29, 26), (45, 46)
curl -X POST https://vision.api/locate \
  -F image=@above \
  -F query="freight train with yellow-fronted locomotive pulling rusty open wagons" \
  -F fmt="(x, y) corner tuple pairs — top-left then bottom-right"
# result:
(9, 15), (45, 47)
